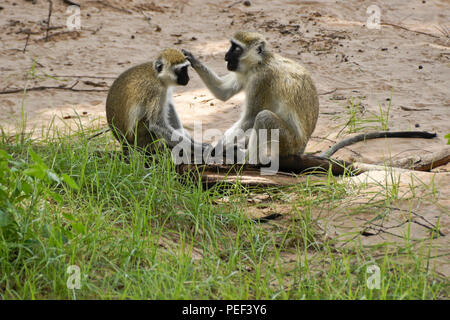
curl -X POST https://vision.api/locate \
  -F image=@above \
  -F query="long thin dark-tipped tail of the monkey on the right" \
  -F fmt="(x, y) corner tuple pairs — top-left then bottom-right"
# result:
(319, 131), (437, 158)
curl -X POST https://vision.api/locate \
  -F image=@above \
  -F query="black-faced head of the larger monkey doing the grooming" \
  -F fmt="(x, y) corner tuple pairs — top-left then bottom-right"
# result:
(225, 31), (266, 72)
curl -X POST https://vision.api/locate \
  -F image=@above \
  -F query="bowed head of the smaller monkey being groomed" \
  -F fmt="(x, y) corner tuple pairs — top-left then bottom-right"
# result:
(154, 49), (189, 86)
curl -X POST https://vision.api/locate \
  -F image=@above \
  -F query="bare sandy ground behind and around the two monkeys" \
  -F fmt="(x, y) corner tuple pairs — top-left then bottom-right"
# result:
(0, 0), (450, 274)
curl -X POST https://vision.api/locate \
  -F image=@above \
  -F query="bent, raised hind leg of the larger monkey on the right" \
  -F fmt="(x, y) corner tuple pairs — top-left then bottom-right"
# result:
(248, 110), (298, 163)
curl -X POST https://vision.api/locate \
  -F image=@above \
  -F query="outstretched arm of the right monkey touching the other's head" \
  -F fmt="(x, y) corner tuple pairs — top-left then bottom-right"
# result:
(183, 50), (242, 101)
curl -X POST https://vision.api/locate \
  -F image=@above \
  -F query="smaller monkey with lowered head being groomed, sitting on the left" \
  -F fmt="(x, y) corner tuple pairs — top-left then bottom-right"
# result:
(106, 49), (206, 154)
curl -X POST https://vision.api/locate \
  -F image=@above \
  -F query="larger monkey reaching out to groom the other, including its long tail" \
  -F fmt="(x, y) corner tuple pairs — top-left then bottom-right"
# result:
(183, 31), (436, 160)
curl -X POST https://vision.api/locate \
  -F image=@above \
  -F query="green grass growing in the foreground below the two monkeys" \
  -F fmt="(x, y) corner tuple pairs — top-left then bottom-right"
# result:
(0, 123), (448, 299)
